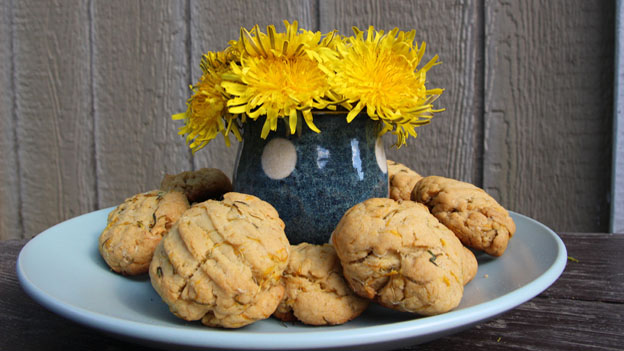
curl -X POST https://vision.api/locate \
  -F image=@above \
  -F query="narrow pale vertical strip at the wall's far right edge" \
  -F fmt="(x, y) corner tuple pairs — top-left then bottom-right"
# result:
(609, 0), (624, 233)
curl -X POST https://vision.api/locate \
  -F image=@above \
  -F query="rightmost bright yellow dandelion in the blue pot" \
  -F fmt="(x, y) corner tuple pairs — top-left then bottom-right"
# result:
(317, 26), (443, 147)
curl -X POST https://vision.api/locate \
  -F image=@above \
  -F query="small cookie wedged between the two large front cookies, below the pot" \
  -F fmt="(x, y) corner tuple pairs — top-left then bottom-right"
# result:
(273, 243), (368, 325)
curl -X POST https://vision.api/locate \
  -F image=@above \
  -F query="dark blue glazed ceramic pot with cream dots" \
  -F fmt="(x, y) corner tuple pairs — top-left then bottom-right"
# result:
(233, 112), (388, 245)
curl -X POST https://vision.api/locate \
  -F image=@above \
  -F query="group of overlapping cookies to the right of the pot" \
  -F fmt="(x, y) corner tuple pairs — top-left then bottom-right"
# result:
(332, 161), (515, 315)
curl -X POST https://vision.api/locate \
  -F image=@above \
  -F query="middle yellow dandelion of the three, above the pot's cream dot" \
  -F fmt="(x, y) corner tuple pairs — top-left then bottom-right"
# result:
(221, 21), (335, 138)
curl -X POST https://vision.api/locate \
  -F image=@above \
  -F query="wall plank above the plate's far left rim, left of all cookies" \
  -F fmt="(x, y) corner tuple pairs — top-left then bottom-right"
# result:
(13, 1), (95, 237)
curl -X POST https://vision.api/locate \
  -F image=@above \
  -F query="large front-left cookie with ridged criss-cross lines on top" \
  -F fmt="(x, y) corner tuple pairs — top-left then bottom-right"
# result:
(149, 193), (290, 328)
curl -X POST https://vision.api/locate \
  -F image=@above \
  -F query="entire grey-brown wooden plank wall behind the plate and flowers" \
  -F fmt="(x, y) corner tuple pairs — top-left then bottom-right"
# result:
(0, 0), (615, 239)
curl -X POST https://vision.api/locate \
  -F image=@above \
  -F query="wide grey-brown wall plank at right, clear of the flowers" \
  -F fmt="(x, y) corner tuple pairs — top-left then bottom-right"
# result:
(483, 0), (614, 231)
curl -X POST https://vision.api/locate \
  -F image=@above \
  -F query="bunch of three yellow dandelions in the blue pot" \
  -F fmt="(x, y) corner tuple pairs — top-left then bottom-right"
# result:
(173, 21), (443, 152)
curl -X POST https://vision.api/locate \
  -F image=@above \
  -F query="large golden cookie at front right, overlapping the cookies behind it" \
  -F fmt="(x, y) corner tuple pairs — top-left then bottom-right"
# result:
(332, 199), (469, 315)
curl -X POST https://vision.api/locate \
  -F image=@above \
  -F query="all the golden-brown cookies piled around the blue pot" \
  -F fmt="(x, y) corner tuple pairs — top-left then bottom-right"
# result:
(99, 161), (515, 328)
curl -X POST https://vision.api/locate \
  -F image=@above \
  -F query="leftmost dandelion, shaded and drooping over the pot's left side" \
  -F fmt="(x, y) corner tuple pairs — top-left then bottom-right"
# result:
(172, 51), (242, 152)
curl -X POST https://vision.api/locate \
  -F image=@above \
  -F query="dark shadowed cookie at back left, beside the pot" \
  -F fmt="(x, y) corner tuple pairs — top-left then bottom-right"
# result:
(160, 168), (232, 203)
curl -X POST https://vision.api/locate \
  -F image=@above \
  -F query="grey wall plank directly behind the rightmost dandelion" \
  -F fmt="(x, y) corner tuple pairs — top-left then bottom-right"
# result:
(319, 0), (482, 185)
